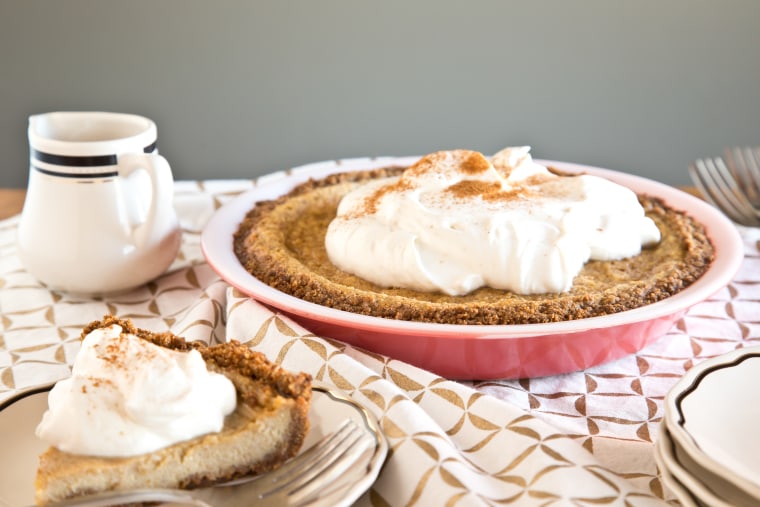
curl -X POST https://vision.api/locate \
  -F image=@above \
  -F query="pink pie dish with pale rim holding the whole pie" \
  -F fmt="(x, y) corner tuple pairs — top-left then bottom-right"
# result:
(201, 157), (744, 379)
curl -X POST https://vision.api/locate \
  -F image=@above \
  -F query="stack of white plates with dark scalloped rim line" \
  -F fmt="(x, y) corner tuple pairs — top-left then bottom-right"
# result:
(655, 347), (760, 507)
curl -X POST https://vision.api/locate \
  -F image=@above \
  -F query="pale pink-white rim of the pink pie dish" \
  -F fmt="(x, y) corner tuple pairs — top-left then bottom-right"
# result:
(200, 156), (744, 340)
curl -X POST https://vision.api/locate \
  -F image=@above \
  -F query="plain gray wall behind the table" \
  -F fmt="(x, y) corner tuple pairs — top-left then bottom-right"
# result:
(0, 0), (760, 187)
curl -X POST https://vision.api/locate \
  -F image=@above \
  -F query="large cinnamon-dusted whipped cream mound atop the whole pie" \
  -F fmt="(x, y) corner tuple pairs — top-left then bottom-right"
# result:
(325, 146), (660, 296)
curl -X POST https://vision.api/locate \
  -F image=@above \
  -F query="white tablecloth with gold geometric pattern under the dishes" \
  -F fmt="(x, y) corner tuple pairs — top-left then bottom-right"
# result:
(0, 180), (760, 506)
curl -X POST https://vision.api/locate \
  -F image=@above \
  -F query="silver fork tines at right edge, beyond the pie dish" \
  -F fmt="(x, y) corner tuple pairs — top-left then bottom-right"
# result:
(689, 154), (760, 227)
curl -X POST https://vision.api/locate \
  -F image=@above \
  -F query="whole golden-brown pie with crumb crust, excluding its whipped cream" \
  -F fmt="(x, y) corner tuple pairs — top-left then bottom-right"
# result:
(233, 167), (714, 325)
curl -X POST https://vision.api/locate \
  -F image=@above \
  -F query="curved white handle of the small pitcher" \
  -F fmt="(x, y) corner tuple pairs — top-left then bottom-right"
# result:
(119, 153), (176, 246)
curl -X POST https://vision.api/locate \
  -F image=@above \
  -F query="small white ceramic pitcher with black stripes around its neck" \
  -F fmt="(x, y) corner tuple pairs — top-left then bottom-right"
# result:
(18, 112), (181, 294)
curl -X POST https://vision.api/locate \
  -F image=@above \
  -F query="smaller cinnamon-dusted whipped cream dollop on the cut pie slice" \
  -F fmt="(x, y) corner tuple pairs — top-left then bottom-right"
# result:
(37, 324), (236, 457)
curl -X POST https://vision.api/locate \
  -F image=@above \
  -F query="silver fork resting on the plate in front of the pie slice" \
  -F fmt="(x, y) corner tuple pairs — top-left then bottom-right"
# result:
(43, 419), (376, 507)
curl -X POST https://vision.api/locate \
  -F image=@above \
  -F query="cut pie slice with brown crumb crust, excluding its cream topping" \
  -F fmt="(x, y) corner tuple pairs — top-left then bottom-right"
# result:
(35, 316), (311, 505)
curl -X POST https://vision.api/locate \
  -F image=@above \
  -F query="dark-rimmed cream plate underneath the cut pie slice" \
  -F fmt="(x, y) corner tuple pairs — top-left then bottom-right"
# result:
(0, 386), (388, 507)
